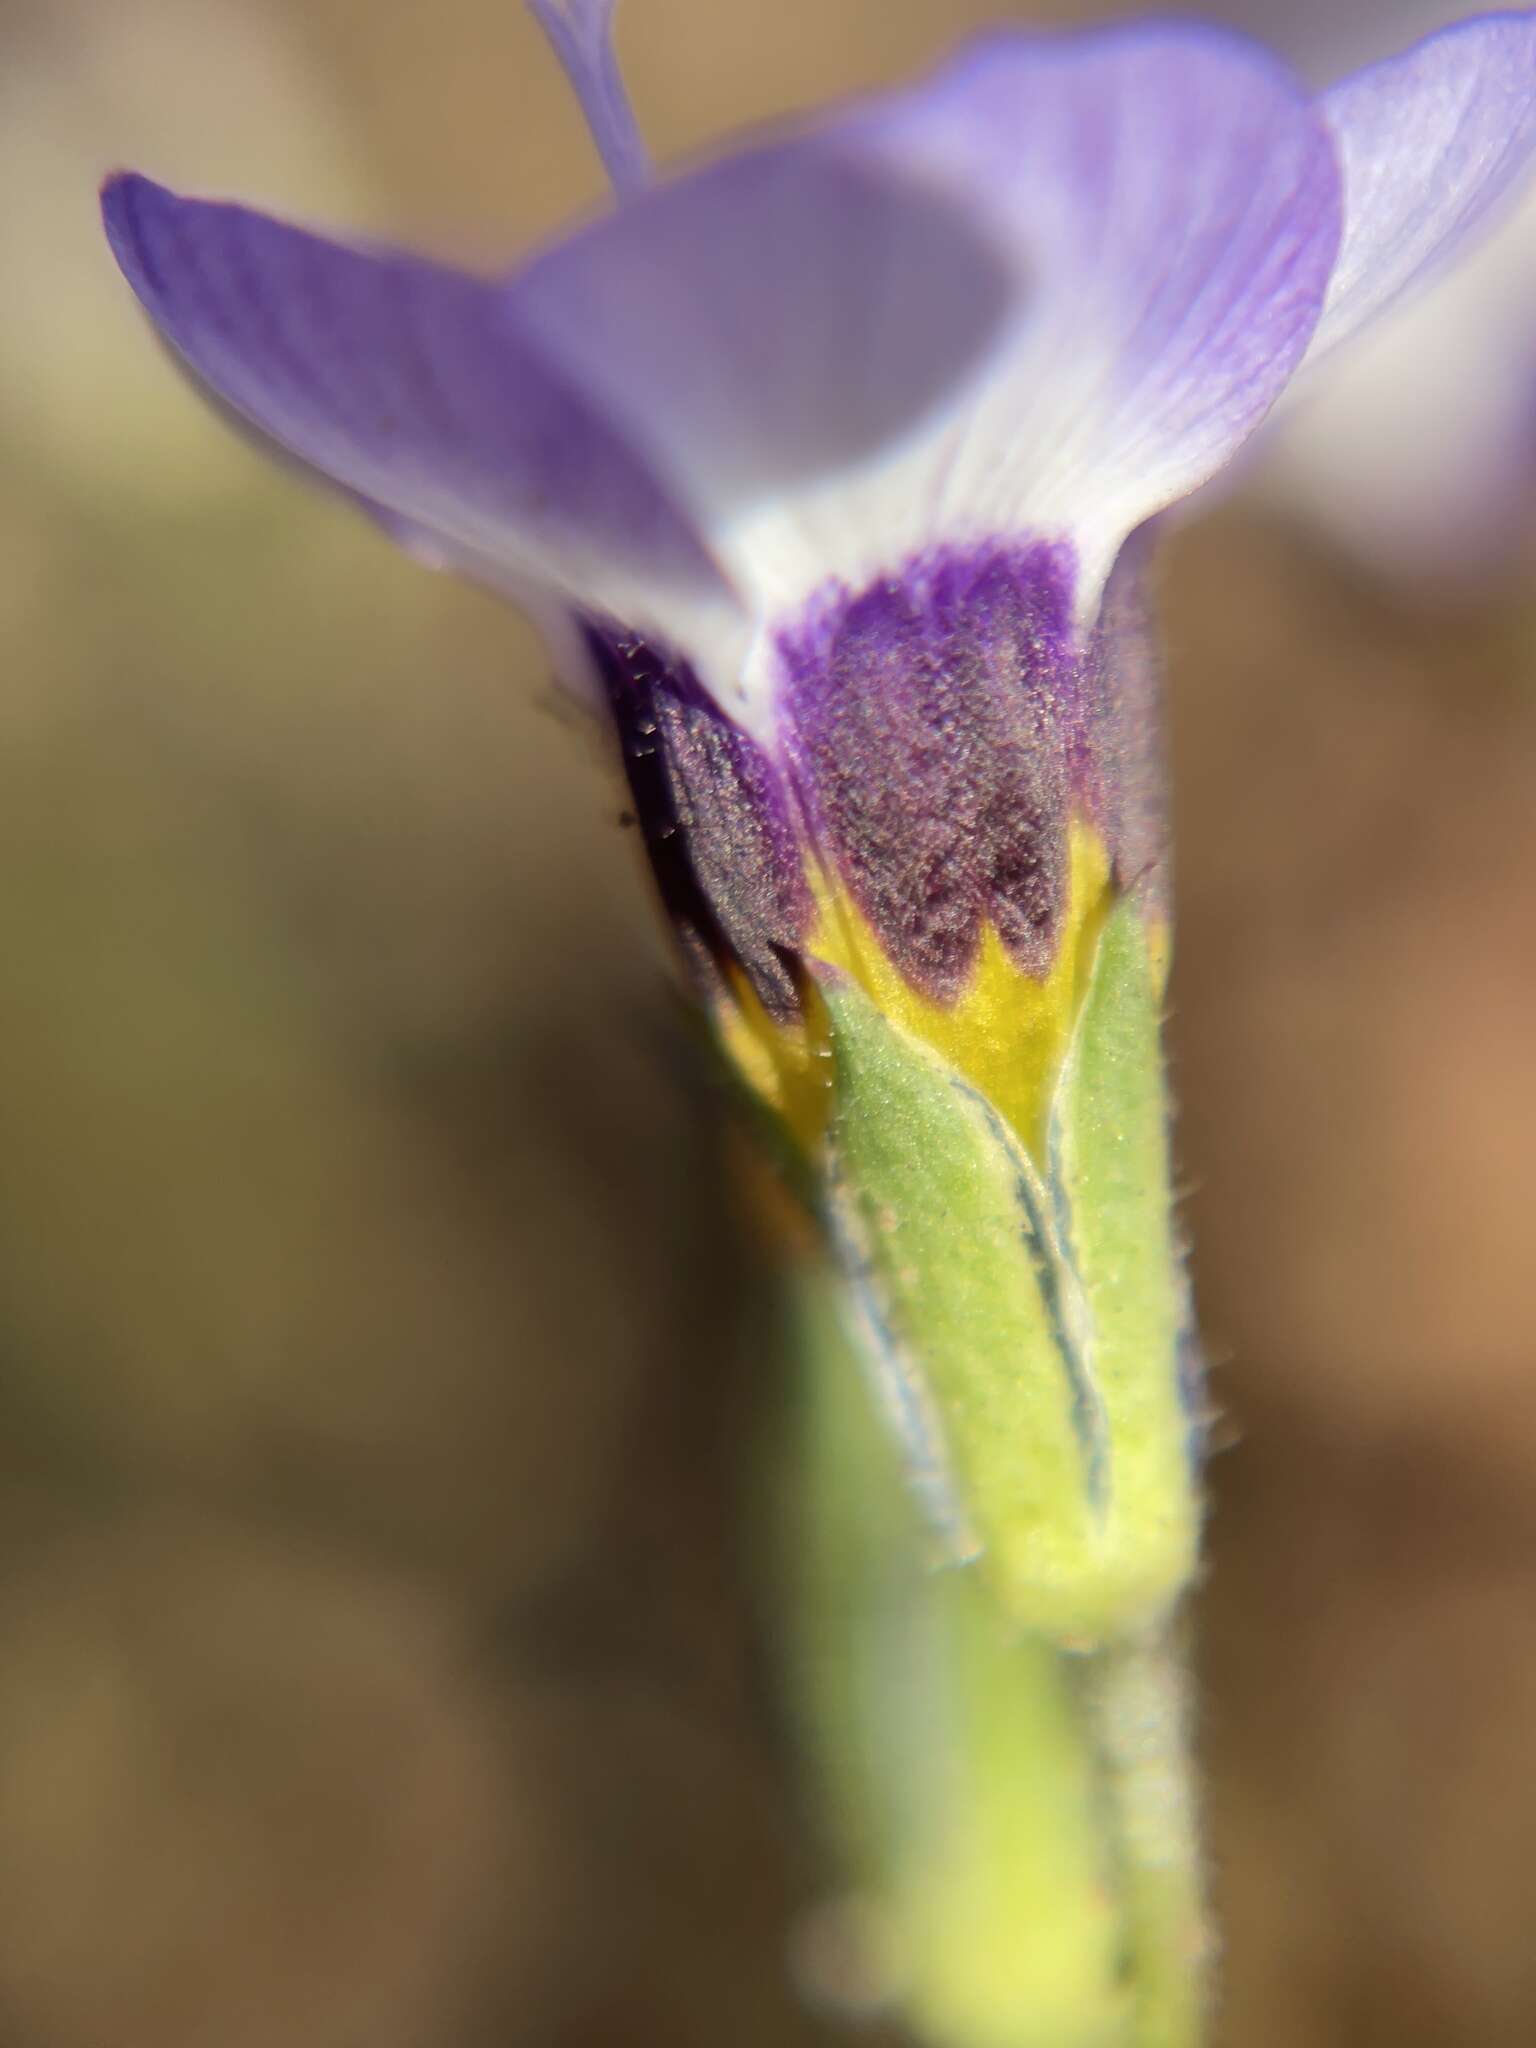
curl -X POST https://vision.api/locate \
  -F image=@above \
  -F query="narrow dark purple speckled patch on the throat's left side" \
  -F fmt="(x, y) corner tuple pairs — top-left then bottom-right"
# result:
(586, 625), (811, 1018)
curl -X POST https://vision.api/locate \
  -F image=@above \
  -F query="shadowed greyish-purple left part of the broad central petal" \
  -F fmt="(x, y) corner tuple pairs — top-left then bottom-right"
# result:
(510, 125), (1016, 655)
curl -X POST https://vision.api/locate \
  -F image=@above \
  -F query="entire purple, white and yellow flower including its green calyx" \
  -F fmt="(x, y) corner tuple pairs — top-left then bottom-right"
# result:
(104, 0), (1536, 1638)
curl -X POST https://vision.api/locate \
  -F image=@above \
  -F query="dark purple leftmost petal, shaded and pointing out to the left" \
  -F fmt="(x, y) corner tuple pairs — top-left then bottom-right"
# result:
(102, 174), (729, 659)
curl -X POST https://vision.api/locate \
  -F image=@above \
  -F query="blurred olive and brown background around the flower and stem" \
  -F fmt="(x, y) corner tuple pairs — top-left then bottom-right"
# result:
(0, 0), (1536, 2048)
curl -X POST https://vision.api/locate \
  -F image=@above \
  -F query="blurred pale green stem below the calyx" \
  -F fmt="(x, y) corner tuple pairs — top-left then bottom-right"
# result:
(780, 1261), (1206, 2048)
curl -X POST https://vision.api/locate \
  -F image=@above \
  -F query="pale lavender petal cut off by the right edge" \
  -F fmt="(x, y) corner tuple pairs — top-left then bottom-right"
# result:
(1311, 12), (1536, 360)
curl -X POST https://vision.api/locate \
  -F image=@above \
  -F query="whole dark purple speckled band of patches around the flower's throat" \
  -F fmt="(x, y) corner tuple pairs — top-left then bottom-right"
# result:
(586, 541), (1165, 1018)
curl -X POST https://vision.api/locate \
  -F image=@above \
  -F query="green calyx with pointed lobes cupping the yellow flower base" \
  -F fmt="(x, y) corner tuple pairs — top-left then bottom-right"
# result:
(819, 899), (1198, 1647)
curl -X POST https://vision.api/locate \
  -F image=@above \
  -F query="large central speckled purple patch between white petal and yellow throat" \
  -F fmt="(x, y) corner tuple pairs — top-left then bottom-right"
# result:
(780, 541), (1112, 1001)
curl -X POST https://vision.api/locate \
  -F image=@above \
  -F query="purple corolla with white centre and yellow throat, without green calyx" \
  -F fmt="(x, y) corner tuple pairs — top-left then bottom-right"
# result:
(104, 0), (1536, 1145)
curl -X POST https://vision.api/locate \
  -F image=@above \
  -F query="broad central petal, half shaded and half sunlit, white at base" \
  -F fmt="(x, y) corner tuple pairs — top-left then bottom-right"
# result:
(514, 27), (1339, 643)
